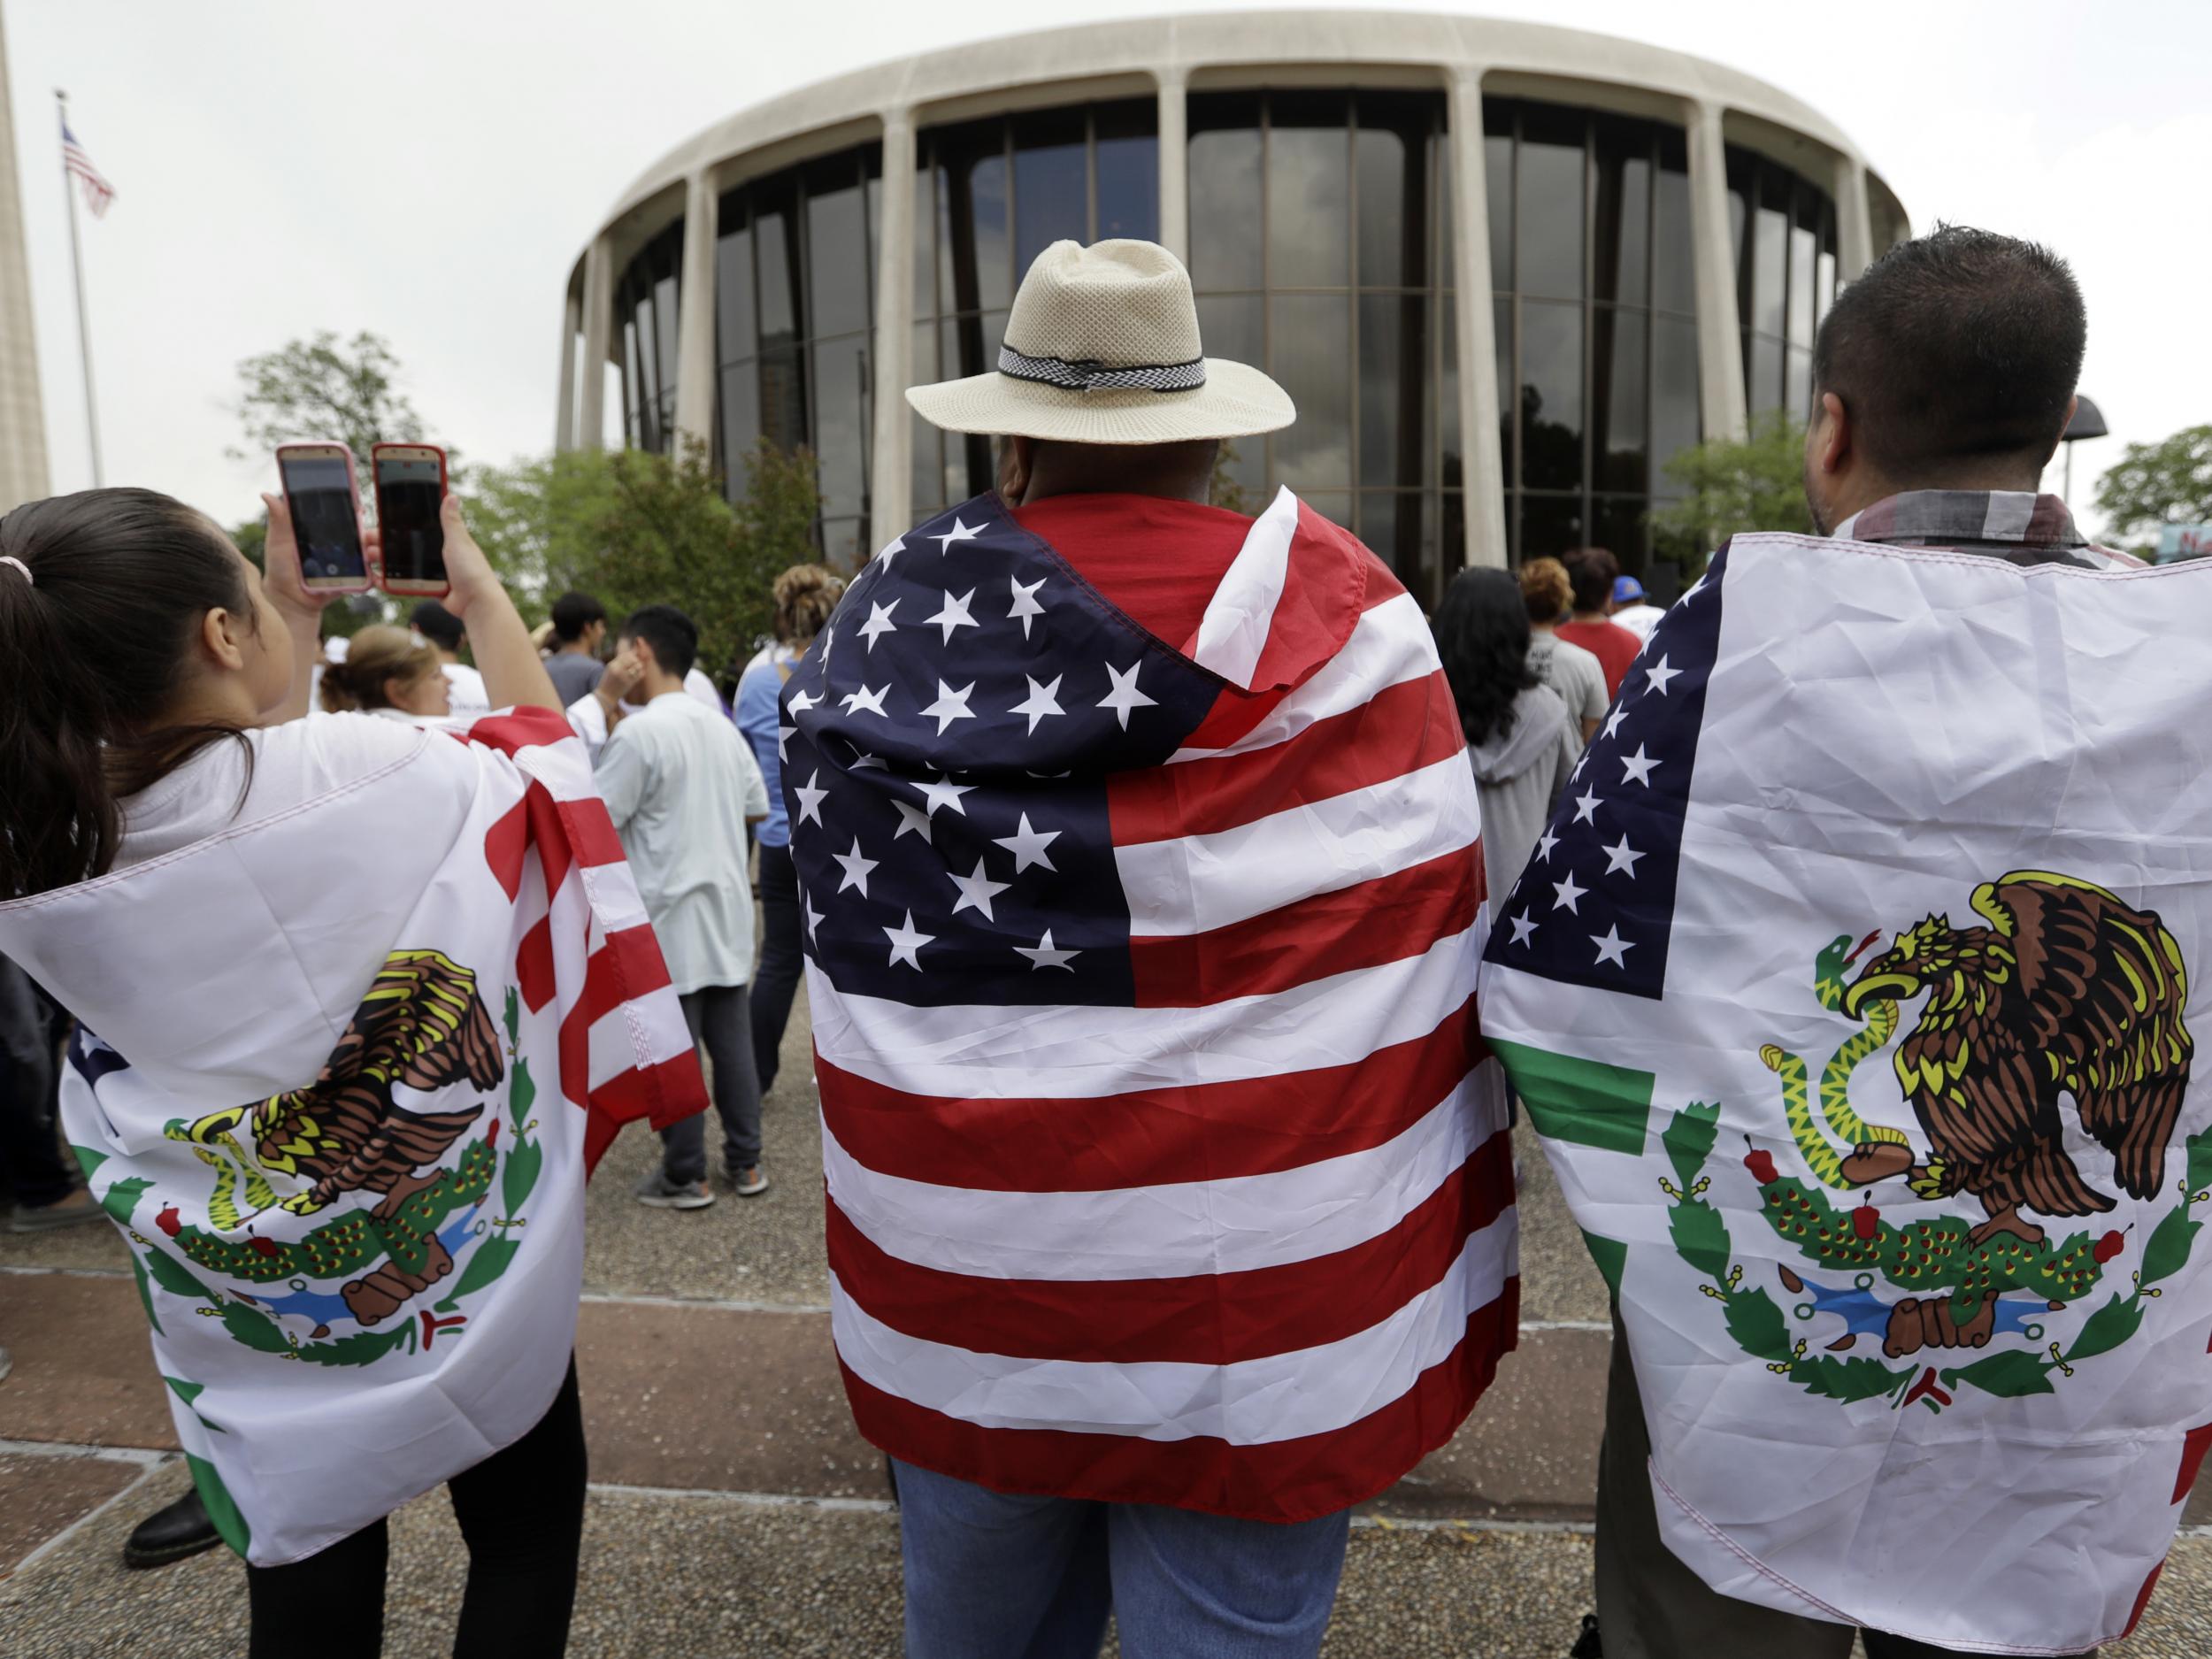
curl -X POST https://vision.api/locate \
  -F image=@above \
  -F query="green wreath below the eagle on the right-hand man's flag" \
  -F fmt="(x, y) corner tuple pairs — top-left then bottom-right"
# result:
(1659, 1102), (2212, 1414)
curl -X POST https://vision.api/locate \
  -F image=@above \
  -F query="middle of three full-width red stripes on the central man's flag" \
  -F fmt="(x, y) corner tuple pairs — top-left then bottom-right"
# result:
(826, 1131), (1513, 1365)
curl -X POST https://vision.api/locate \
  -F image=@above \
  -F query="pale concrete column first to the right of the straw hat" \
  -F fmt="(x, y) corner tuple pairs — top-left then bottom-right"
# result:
(1447, 71), (1507, 569)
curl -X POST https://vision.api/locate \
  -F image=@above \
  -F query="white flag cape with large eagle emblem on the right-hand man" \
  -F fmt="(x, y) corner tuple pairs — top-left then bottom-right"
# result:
(1482, 535), (2212, 1653)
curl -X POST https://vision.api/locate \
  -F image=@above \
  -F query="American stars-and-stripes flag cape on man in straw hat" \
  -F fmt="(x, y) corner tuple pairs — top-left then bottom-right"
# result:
(783, 491), (1517, 1522)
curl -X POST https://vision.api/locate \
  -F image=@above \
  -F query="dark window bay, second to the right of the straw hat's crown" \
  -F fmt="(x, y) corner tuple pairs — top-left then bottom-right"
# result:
(1482, 97), (1701, 597)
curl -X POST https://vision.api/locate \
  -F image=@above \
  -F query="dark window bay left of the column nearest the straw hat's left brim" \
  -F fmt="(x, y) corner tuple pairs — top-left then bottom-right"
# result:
(715, 144), (883, 569)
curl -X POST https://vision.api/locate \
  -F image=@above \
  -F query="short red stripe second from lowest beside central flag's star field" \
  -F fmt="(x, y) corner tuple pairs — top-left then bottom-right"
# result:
(1106, 671), (1467, 848)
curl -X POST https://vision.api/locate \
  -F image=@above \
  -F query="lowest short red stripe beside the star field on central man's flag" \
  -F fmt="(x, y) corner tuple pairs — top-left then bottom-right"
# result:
(1128, 848), (1482, 1009)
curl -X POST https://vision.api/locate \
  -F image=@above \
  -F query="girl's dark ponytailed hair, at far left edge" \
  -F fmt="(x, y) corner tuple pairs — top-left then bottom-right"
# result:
(0, 489), (257, 898)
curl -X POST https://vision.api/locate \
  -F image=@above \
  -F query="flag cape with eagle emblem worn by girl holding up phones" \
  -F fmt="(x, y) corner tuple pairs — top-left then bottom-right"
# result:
(0, 710), (706, 1564)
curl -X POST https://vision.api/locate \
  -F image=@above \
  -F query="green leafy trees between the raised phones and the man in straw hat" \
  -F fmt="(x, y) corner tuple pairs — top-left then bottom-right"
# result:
(469, 441), (821, 677)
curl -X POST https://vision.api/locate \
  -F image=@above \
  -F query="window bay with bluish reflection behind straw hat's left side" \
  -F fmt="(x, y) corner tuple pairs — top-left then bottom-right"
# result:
(914, 97), (1159, 522)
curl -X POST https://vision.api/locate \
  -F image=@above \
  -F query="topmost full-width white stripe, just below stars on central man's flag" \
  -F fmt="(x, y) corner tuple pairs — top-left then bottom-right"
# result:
(808, 929), (1482, 1100)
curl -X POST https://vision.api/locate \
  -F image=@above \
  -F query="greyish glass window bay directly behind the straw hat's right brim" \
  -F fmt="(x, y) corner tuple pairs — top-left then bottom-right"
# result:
(1188, 91), (1464, 604)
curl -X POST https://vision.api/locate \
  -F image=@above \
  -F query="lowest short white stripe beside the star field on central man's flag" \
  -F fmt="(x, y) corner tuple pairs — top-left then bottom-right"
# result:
(1113, 755), (1482, 938)
